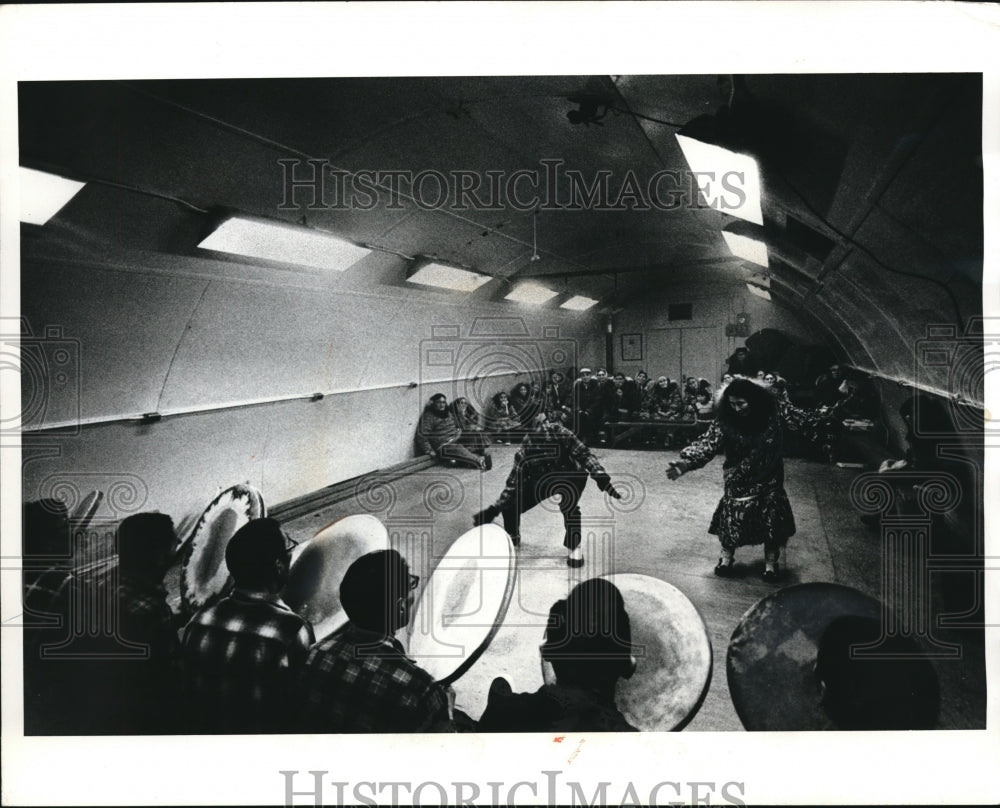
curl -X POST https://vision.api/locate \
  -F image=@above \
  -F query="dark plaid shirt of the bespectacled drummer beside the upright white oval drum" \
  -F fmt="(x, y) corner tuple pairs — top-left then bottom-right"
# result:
(296, 623), (451, 733)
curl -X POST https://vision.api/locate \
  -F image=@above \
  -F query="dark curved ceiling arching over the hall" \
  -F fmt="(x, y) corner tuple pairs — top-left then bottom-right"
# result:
(19, 74), (983, 400)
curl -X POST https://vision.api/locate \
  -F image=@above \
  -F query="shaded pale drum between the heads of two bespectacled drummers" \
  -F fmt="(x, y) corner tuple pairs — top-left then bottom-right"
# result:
(282, 513), (389, 641)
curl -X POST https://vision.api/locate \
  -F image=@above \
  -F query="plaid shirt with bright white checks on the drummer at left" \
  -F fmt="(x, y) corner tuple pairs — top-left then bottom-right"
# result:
(183, 589), (315, 733)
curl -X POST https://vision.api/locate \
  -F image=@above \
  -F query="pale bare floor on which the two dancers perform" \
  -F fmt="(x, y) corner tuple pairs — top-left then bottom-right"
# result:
(286, 446), (986, 732)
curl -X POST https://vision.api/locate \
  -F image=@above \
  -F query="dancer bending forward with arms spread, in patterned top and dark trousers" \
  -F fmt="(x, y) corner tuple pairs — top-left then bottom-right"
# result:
(472, 413), (621, 567)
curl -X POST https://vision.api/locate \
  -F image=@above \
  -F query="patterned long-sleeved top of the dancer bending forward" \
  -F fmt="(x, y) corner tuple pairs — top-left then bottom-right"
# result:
(496, 421), (610, 510)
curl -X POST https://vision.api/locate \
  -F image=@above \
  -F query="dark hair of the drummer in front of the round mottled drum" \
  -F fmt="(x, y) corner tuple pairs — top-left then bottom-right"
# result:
(542, 578), (632, 686)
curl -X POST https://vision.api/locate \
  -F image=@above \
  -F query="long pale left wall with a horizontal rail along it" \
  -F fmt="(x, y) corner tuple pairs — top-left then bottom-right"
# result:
(21, 249), (604, 519)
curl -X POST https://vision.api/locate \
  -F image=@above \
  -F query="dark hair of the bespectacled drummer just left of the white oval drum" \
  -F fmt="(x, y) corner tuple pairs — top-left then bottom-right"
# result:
(340, 550), (410, 634)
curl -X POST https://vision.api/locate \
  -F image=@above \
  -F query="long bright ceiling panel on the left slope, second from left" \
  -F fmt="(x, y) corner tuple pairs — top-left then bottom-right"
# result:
(198, 216), (371, 272)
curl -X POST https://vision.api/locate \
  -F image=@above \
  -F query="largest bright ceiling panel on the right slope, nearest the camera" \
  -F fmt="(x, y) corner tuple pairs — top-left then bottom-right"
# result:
(676, 133), (764, 225)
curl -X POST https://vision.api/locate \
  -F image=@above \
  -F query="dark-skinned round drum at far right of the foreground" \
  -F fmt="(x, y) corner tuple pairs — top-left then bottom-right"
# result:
(726, 583), (882, 731)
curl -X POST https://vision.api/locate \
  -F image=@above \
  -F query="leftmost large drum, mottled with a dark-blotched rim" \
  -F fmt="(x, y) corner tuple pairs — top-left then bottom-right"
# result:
(181, 485), (267, 612)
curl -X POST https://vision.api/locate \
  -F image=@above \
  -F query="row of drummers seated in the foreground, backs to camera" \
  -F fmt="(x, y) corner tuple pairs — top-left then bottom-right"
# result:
(25, 503), (937, 734)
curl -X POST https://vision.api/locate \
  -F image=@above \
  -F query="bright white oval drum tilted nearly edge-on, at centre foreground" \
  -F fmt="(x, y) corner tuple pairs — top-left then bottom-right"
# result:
(409, 524), (517, 688)
